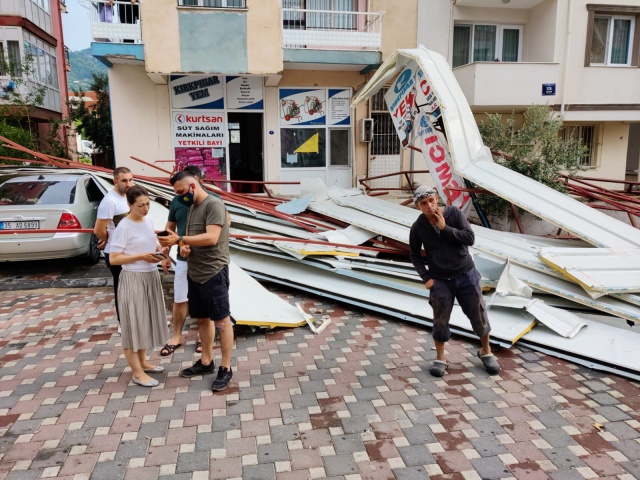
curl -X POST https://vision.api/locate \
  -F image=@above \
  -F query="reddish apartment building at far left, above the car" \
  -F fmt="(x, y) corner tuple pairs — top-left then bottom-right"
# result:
(0, 0), (69, 133)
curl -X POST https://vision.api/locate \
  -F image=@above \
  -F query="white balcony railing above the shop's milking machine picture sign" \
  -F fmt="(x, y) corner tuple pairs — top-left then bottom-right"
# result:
(282, 8), (384, 50)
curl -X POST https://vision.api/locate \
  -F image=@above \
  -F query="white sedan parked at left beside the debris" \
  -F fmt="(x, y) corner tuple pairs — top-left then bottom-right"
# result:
(0, 173), (107, 264)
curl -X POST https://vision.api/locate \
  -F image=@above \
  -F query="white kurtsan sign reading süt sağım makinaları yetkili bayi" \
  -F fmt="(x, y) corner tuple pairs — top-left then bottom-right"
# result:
(173, 110), (227, 148)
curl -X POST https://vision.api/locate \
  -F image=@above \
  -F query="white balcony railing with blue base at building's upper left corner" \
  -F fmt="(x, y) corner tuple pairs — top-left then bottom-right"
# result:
(91, 0), (142, 43)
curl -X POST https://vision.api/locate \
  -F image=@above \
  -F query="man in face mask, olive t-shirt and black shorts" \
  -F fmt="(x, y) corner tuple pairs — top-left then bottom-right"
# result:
(158, 171), (233, 391)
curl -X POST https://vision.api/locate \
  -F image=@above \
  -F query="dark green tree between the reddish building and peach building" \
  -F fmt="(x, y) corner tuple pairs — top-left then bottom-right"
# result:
(70, 72), (113, 166)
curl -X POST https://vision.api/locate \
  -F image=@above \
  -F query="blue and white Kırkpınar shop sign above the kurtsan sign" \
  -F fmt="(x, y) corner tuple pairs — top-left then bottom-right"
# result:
(169, 75), (224, 110)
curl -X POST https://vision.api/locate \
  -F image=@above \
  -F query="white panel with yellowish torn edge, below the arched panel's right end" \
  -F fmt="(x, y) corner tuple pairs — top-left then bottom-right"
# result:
(540, 248), (640, 294)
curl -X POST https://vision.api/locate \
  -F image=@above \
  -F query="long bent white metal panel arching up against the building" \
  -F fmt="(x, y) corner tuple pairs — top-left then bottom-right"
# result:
(353, 46), (640, 247)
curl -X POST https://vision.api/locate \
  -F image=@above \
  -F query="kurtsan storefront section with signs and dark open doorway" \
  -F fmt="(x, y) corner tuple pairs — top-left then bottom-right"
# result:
(169, 75), (264, 192)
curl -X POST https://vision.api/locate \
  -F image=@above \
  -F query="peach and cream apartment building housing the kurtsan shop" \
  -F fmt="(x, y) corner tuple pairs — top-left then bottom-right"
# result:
(92, 0), (418, 194)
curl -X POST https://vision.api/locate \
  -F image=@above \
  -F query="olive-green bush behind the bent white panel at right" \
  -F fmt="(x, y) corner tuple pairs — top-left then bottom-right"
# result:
(478, 105), (588, 216)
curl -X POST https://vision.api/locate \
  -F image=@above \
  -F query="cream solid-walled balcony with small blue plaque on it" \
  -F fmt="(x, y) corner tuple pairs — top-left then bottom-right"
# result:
(453, 62), (561, 112)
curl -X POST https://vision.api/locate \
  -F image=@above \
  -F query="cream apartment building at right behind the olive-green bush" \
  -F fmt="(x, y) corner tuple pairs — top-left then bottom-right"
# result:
(418, 0), (640, 180)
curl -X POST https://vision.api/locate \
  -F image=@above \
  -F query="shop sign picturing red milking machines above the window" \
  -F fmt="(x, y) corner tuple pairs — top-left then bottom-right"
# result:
(279, 88), (327, 127)
